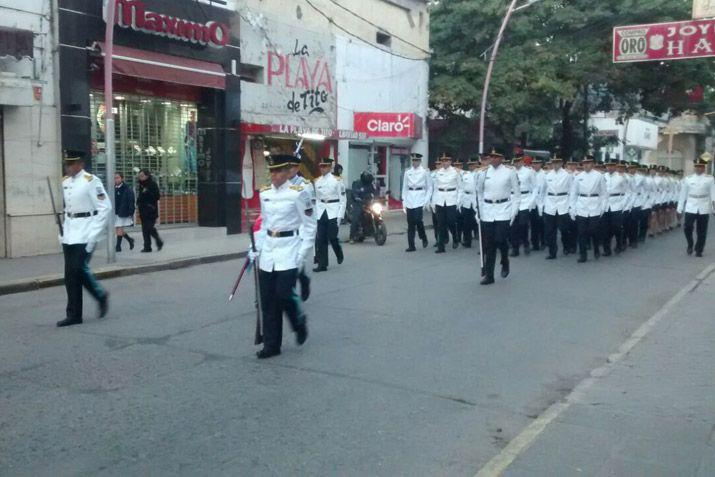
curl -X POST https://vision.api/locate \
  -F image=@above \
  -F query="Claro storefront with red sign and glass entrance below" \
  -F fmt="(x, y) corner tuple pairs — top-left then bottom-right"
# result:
(348, 112), (426, 208)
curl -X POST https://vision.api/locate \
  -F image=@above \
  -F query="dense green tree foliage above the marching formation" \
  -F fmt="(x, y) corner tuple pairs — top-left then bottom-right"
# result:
(430, 0), (715, 156)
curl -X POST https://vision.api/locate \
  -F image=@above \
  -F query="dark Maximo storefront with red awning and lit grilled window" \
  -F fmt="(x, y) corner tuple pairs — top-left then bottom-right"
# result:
(59, 0), (241, 233)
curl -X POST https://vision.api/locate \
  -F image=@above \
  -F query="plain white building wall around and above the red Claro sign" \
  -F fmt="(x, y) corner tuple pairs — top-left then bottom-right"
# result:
(335, 36), (429, 187)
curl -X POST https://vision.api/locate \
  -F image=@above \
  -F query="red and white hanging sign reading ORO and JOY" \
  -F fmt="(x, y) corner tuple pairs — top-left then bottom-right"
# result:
(613, 20), (715, 63)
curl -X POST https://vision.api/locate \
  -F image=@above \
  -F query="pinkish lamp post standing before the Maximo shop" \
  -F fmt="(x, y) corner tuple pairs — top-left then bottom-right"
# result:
(104, 0), (117, 263)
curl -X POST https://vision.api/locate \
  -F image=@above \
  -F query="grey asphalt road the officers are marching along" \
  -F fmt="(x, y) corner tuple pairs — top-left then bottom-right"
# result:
(0, 225), (712, 476)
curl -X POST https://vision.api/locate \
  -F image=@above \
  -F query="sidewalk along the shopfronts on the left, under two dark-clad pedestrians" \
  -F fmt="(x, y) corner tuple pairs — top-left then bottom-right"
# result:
(0, 210), (414, 295)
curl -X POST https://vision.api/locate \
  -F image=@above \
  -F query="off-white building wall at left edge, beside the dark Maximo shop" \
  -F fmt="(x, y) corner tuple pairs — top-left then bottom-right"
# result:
(0, 0), (62, 257)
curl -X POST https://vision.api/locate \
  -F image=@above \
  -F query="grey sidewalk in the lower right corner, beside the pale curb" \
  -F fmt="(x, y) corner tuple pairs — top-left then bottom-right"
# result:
(503, 264), (715, 477)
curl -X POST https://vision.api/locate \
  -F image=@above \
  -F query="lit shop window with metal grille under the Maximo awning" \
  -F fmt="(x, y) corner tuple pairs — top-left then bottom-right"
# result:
(90, 92), (198, 224)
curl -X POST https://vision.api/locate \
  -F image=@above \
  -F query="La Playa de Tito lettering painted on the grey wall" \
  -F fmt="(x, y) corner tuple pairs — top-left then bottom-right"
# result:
(267, 39), (333, 114)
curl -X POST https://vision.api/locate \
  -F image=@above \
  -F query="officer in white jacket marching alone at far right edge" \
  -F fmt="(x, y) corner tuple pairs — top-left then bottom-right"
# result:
(678, 154), (715, 257)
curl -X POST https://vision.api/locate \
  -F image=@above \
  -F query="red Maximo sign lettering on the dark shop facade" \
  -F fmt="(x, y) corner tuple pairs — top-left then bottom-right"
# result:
(105, 0), (231, 48)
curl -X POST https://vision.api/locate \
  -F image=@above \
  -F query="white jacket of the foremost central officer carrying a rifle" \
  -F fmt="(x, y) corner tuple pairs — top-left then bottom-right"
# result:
(256, 180), (316, 272)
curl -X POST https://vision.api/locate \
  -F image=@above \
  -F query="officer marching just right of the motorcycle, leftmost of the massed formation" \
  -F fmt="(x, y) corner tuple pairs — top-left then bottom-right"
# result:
(402, 153), (432, 252)
